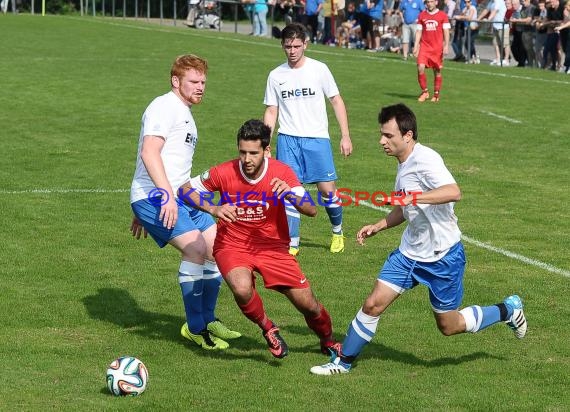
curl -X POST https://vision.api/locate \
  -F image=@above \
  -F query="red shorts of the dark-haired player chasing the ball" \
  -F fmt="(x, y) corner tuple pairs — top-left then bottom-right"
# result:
(214, 248), (310, 289)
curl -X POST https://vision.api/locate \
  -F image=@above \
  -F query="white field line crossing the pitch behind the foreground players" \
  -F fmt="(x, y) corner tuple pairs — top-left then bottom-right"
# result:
(0, 188), (570, 278)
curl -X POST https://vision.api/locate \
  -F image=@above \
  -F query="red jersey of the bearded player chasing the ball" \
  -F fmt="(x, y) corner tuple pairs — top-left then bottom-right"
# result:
(193, 158), (302, 251)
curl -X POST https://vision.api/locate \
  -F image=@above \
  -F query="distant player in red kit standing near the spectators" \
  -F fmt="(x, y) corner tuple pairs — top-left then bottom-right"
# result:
(414, 0), (451, 102)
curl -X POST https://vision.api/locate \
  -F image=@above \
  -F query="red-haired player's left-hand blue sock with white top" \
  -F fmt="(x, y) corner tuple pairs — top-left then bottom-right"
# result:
(178, 261), (206, 334)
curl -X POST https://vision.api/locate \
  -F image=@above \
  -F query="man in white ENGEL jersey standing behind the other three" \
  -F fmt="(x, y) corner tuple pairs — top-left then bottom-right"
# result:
(263, 23), (352, 256)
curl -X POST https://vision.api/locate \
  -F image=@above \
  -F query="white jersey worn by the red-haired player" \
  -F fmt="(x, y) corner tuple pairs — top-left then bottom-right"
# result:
(131, 91), (198, 203)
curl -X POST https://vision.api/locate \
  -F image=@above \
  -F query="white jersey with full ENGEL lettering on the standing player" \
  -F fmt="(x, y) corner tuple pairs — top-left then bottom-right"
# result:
(263, 57), (339, 139)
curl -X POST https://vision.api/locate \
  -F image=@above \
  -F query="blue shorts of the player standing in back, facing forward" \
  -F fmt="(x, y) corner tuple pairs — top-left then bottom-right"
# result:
(277, 133), (337, 183)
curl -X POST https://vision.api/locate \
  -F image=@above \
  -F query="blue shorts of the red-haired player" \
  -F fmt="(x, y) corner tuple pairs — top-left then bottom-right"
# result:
(131, 199), (215, 247)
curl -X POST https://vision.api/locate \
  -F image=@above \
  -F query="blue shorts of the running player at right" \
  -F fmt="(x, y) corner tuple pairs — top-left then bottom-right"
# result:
(378, 242), (466, 313)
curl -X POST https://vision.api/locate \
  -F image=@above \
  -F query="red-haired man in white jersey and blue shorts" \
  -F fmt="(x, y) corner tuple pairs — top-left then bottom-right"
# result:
(131, 54), (241, 350)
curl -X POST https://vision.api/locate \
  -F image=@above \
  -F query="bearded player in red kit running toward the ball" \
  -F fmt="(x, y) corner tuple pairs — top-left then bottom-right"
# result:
(179, 120), (338, 358)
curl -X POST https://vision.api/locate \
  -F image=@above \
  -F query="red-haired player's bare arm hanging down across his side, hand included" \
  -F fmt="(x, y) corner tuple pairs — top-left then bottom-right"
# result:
(141, 135), (178, 229)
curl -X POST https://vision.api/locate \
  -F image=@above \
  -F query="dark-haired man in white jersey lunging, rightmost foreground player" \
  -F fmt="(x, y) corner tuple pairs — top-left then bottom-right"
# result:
(311, 104), (527, 375)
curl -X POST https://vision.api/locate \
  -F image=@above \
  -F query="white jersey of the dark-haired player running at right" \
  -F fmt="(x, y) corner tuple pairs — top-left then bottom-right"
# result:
(395, 143), (461, 262)
